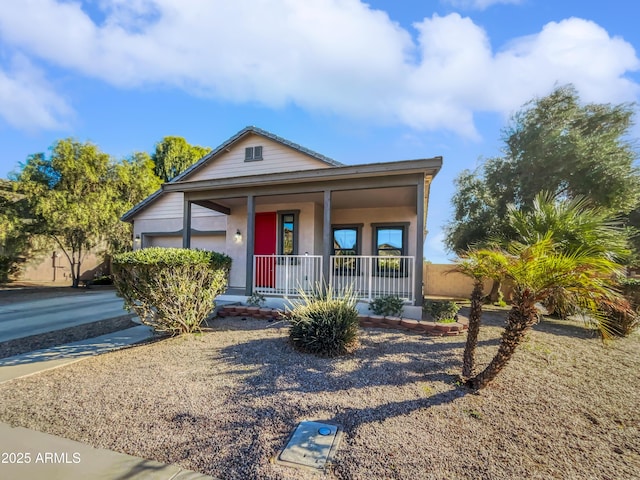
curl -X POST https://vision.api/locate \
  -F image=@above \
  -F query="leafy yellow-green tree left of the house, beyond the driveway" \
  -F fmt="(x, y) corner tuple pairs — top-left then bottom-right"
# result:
(16, 139), (118, 287)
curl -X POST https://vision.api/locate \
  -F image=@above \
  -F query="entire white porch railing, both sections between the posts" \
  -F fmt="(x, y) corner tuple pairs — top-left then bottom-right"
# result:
(253, 255), (415, 303)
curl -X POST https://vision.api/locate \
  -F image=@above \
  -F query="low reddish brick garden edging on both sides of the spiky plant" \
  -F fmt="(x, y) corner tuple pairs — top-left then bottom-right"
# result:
(218, 305), (469, 337)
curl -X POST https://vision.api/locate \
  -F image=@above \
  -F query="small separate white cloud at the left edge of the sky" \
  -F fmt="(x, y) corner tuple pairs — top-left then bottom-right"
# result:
(0, 56), (73, 130)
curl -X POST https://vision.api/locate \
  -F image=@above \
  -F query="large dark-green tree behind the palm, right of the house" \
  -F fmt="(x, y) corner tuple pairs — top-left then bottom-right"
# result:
(446, 86), (640, 253)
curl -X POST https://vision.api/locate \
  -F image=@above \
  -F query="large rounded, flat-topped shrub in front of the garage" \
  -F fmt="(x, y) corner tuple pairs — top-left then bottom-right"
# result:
(112, 248), (231, 335)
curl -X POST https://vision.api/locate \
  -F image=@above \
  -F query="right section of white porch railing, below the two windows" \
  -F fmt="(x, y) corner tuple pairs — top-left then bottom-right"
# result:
(329, 255), (415, 303)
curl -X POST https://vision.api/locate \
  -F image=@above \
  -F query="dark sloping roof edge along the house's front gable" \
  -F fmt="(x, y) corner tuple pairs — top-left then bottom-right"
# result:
(121, 125), (343, 222)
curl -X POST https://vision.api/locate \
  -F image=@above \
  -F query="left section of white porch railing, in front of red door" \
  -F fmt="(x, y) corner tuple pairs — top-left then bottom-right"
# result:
(253, 255), (322, 296)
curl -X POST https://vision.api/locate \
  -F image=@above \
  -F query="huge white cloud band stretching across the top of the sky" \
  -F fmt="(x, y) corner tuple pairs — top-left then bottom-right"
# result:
(0, 0), (640, 138)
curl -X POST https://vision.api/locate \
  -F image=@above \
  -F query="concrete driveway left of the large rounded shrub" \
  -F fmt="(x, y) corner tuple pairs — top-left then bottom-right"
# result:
(0, 290), (127, 342)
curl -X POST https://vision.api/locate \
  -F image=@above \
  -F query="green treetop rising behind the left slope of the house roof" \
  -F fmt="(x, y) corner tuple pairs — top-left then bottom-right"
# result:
(152, 137), (211, 182)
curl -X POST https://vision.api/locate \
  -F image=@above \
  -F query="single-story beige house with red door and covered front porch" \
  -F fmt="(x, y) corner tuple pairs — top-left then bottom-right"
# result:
(122, 127), (442, 305)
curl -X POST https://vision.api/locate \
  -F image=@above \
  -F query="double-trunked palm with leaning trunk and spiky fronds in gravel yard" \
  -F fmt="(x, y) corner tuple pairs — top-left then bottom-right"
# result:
(457, 192), (632, 388)
